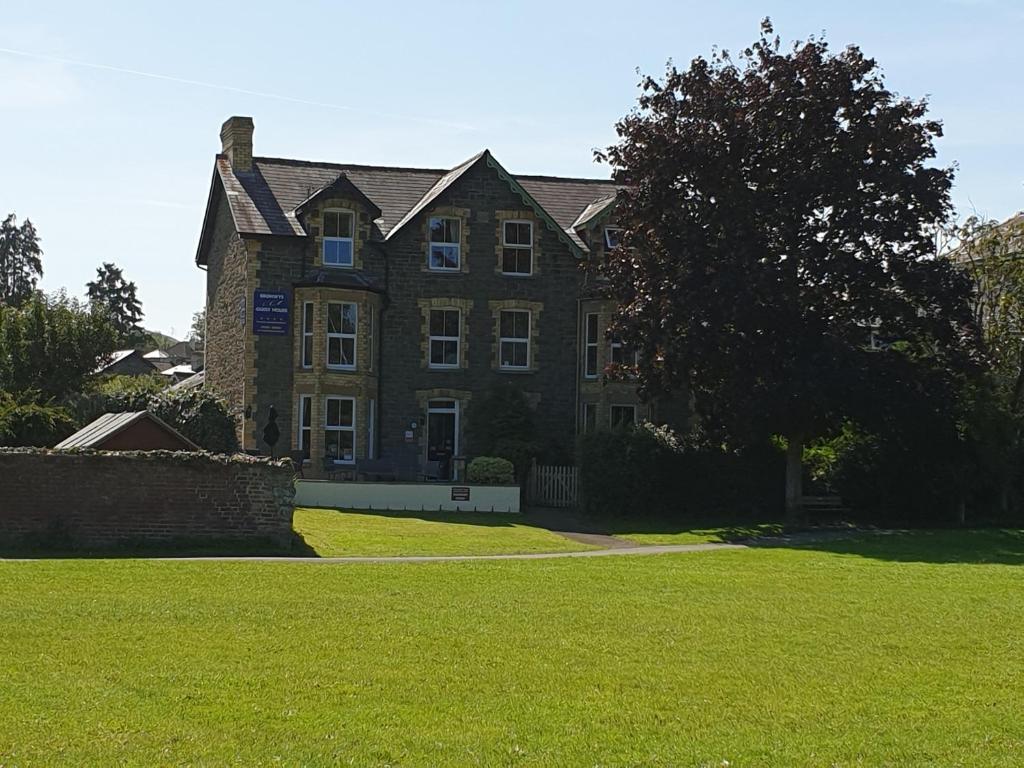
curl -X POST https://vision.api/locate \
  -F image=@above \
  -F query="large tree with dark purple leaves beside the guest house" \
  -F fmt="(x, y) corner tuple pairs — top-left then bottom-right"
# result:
(598, 19), (976, 515)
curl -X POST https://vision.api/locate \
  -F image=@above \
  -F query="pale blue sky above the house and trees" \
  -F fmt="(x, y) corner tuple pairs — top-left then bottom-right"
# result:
(0, 0), (1024, 338)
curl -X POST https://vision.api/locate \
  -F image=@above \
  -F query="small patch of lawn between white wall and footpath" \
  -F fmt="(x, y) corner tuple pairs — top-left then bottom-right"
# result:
(294, 507), (593, 557)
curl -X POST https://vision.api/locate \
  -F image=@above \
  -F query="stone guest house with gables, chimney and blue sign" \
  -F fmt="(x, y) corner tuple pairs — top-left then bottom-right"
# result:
(196, 117), (667, 473)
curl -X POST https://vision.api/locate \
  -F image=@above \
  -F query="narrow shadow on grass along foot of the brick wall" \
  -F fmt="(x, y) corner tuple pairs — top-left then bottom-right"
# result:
(0, 531), (318, 560)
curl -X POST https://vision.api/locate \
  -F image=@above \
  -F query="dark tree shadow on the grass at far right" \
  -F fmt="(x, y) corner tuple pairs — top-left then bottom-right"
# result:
(751, 528), (1024, 565)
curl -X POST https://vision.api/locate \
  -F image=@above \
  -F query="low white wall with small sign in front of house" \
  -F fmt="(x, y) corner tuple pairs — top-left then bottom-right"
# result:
(295, 480), (519, 512)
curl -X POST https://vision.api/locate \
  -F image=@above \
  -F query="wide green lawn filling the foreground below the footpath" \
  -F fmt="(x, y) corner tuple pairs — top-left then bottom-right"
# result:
(0, 531), (1024, 768)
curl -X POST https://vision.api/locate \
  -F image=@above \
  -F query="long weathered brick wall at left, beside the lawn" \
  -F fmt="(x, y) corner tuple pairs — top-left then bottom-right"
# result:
(0, 449), (295, 547)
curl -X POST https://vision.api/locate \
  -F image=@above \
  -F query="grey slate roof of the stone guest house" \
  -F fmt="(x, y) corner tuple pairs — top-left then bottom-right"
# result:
(197, 151), (616, 263)
